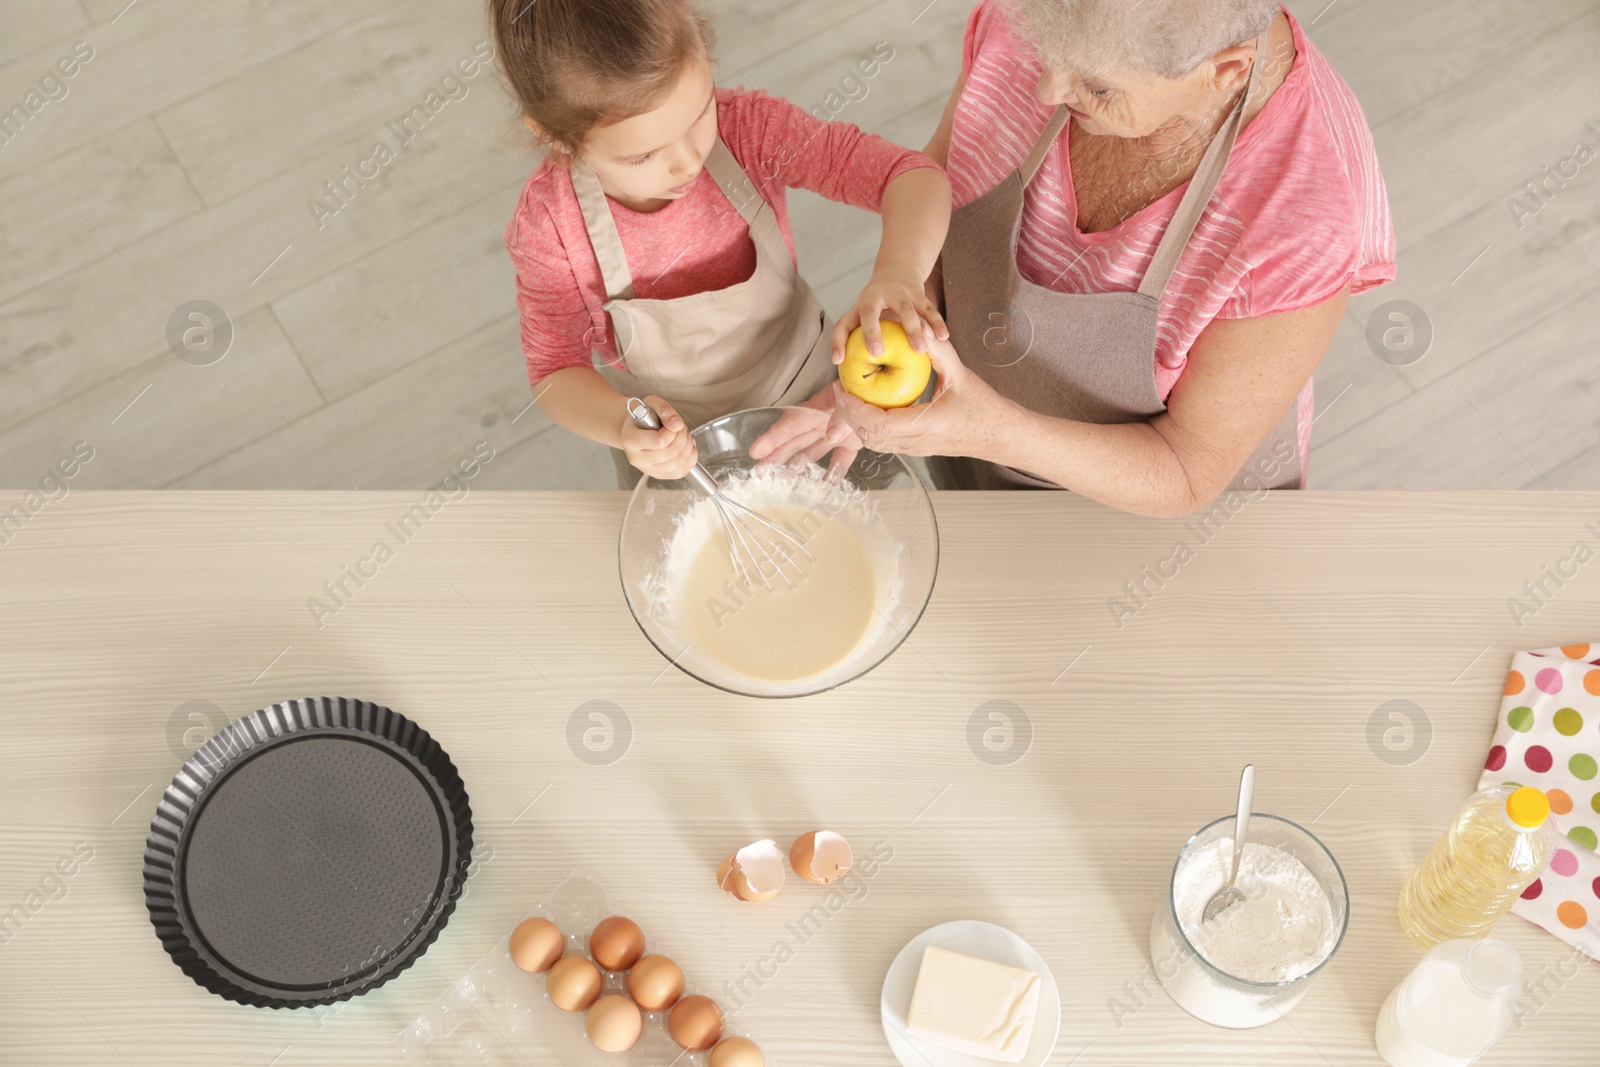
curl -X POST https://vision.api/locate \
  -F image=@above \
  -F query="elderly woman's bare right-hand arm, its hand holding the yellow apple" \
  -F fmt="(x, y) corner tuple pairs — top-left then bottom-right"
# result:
(838, 288), (1350, 515)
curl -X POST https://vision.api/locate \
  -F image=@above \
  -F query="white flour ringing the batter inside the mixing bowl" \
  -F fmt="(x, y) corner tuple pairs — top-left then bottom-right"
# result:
(640, 464), (902, 675)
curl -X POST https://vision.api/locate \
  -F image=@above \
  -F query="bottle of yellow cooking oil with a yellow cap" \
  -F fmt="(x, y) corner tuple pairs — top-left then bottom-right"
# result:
(1400, 784), (1560, 949)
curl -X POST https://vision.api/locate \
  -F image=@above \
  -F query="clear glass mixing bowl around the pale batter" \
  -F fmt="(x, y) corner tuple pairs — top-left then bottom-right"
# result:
(618, 408), (939, 697)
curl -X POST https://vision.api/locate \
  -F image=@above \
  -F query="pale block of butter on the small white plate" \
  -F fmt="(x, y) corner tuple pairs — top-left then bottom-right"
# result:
(906, 945), (1038, 1064)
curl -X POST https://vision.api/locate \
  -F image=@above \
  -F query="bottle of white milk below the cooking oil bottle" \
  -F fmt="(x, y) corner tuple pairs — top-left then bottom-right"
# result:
(1378, 939), (1522, 1067)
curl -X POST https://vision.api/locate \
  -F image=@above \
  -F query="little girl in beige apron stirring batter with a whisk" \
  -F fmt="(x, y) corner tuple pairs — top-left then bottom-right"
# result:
(490, 0), (950, 488)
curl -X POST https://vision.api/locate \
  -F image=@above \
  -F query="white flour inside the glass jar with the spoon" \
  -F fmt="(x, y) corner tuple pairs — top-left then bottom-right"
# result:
(1150, 838), (1339, 1029)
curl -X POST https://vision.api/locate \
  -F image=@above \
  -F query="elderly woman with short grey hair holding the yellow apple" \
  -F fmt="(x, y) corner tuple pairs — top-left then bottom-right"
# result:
(763, 0), (1394, 515)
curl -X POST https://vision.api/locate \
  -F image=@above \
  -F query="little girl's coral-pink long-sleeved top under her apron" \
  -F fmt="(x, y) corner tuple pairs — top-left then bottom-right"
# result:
(506, 88), (936, 384)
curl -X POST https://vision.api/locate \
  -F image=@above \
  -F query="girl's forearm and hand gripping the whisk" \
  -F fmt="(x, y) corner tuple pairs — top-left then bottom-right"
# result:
(533, 366), (699, 480)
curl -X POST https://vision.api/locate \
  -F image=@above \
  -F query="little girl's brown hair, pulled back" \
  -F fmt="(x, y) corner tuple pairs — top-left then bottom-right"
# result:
(488, 0), (717, 155)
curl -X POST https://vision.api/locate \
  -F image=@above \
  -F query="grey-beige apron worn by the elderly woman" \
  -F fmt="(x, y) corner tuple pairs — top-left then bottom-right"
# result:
(930, 35), (1301, 490)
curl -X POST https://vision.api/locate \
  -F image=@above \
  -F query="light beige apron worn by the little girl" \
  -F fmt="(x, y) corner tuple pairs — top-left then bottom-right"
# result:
(573, 138), (838, 488)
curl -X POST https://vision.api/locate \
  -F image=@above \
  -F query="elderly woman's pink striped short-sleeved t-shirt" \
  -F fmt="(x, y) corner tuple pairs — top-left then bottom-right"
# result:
(946, 0), (1395, 464)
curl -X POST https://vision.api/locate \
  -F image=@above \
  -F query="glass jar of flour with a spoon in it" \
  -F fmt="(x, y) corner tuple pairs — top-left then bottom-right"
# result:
(1150, 814), (1350, 1030)
